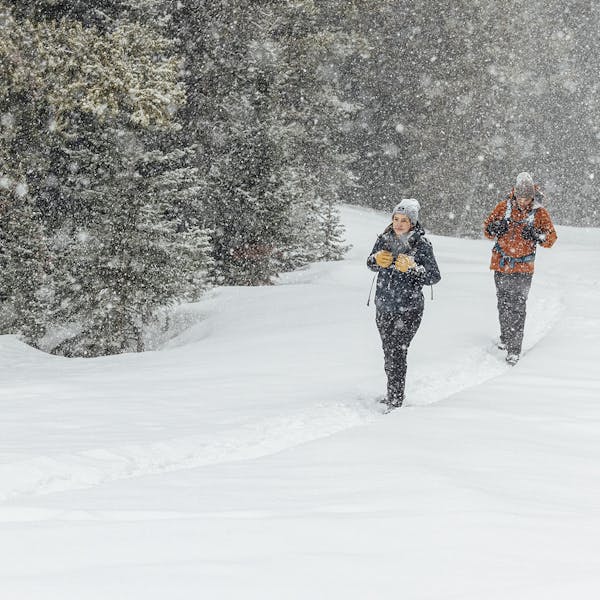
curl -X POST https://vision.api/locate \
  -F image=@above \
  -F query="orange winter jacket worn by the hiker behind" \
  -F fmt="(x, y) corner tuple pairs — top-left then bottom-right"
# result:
(483, 190), (557, 273)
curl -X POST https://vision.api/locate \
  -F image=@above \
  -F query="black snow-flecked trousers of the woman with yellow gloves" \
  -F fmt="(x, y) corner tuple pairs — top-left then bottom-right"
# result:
(375, 306), (423, 406)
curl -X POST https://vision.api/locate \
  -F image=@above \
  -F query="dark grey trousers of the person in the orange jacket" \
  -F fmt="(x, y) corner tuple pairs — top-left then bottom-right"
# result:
(494, 271), (533, 354)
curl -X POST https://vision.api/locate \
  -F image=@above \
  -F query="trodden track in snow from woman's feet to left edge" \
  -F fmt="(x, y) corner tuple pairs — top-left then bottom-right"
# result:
(0, 403), (377, 502)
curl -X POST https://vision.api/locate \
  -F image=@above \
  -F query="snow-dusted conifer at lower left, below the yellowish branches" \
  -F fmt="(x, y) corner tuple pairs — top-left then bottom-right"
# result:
(47, 124), (208, 356)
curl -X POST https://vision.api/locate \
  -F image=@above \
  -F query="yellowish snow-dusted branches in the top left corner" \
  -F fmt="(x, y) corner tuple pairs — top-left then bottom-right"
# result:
(0, 3), (185, 128)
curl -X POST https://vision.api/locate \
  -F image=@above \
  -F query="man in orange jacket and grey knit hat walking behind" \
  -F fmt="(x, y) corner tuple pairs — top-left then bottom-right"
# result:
(484, 172), (557, 365)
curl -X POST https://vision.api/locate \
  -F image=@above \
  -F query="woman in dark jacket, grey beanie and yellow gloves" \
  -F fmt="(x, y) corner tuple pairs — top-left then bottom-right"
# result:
(367, 199), (441, 409)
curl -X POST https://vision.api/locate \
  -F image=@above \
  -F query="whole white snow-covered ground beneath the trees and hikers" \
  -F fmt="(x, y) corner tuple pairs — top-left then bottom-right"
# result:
(0, 207), (600, 600)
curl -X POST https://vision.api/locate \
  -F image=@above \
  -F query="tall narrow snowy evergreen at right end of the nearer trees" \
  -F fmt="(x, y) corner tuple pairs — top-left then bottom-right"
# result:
(269, 1), (357, 268)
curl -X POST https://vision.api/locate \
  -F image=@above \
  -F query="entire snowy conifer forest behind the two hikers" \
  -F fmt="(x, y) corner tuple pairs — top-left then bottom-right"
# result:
(0, 0), (600, 357)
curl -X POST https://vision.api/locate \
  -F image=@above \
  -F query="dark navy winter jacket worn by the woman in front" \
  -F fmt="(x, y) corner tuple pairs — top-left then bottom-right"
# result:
(367, 223), (441, 313)
